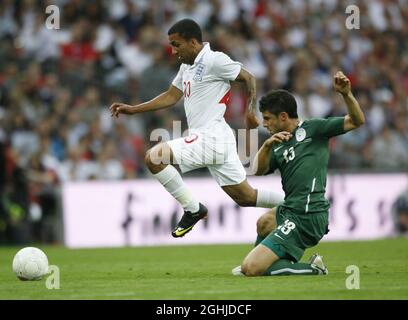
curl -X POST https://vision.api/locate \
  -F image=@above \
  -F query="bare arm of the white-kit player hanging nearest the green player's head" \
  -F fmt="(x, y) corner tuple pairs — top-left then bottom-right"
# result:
(235, 68), (260, 129)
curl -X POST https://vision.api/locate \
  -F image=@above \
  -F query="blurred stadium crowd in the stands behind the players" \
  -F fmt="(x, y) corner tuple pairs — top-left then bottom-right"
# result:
(0, 0), (408, 240)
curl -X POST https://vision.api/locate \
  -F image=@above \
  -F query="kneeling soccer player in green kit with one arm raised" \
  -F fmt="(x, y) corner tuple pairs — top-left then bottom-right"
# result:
(232, 72), (365, 276)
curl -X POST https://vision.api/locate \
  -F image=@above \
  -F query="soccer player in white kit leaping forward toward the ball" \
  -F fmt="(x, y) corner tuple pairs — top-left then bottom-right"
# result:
(110, 19), (283, 237)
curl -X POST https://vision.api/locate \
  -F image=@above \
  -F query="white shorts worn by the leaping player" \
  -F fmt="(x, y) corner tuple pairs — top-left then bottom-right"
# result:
(166, 123), (246, 187)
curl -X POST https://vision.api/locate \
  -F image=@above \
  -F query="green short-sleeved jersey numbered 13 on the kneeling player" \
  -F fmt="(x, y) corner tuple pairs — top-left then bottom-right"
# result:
(268, 117), (345, 214)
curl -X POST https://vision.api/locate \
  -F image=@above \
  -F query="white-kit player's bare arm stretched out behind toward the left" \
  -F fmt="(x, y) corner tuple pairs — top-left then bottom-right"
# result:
(109, 85), (183, 117)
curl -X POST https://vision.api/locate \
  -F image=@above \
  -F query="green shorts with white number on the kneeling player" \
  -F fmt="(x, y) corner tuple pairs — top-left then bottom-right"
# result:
(261, 206), (329, 262)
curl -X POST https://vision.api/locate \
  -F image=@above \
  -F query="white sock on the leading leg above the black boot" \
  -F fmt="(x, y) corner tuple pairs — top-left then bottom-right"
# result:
(154, 165), (200, 212)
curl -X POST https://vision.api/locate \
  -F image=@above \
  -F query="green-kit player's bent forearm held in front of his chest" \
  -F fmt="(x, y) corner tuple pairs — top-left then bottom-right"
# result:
(252, 131), (292, 176)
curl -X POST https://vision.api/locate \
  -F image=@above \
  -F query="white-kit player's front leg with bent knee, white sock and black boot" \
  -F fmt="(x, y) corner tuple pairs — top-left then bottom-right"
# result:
(145, 143), (207, 238)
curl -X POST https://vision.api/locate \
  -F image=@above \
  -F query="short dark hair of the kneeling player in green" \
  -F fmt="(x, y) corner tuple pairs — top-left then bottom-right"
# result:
(259, 89), (298, 118)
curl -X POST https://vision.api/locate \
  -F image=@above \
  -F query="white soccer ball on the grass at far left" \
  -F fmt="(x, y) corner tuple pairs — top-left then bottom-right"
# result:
(13, 247), (48, 280)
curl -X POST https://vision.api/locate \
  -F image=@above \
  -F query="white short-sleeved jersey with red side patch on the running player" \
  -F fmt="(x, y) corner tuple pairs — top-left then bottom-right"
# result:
(172, 42), (242, 129)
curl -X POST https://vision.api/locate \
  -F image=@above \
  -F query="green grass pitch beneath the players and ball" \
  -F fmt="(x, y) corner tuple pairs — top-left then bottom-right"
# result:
(0, 239), (408, 300)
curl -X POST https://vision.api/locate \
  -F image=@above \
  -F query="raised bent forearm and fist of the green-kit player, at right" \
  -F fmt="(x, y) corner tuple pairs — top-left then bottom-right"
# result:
(334, 71), (365, 131)
